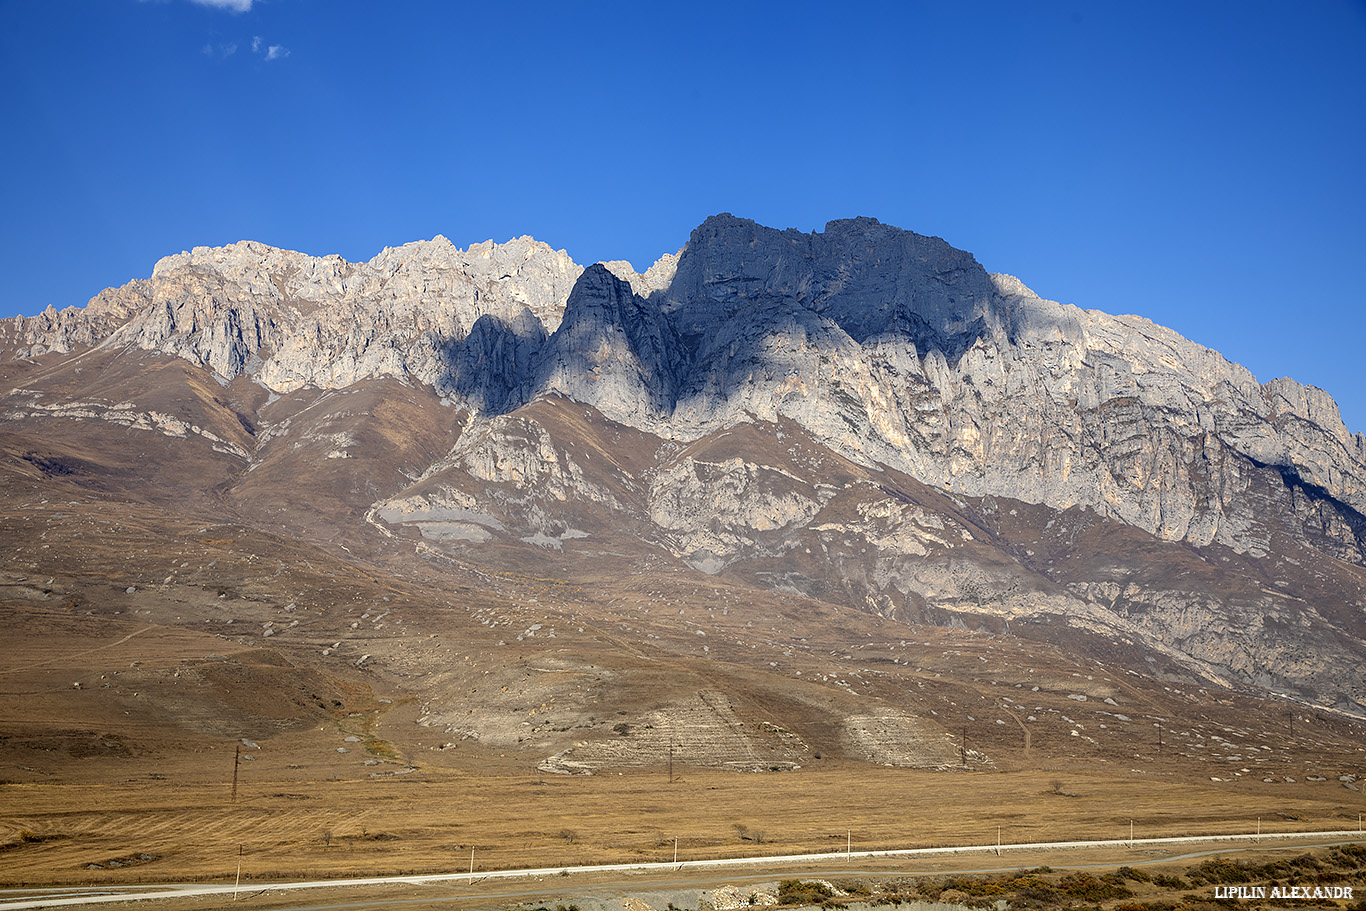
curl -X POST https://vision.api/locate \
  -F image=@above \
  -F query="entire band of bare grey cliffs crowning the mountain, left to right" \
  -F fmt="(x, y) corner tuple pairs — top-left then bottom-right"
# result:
(0, 214), (1366, 561)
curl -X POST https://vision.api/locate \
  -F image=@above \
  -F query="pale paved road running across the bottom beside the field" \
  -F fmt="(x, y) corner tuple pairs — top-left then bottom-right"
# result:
(0, 829), (1366, 911)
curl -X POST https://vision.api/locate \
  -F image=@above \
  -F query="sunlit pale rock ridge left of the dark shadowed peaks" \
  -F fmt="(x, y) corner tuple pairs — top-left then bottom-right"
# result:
(0, 235), (582, 393)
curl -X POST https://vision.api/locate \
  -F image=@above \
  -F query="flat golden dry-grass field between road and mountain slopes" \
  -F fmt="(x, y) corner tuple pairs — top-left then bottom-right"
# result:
(0, 763), (1361, 884)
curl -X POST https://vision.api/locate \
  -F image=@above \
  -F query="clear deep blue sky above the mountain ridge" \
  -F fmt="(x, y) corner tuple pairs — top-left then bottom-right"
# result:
(0, 0), (1366, 430)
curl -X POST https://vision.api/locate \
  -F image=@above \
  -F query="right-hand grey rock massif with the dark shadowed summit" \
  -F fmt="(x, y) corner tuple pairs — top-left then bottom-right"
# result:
(535, 216), (1366, 560)
